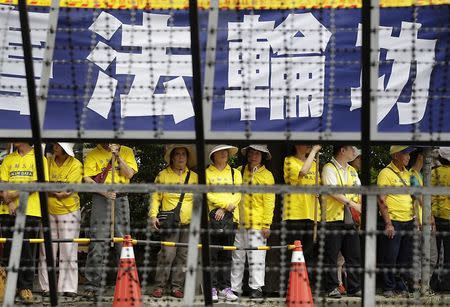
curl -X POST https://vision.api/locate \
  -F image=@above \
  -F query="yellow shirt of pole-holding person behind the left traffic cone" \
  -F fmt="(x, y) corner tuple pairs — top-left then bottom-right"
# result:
(84, 144), (138, 184)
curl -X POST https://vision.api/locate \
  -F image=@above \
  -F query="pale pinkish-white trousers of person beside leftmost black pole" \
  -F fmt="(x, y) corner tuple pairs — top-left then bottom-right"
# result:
(38, 210), (81, 293)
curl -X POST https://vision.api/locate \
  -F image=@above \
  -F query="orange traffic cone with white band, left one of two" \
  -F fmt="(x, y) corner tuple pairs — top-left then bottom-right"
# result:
(113, 235), (143, 307)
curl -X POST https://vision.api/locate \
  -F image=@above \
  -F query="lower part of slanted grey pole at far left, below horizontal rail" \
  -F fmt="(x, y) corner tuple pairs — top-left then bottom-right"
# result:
(3, 192), (28, 307)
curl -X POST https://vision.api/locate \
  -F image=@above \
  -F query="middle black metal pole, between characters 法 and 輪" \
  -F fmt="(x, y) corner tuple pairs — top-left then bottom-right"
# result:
(189, 0), (213, 306)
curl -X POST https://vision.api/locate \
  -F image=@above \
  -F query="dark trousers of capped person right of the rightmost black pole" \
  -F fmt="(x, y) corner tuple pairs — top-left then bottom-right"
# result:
(381, 220), (415, 291)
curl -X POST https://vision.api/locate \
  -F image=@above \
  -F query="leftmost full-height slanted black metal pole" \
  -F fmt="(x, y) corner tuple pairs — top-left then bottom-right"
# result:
(19, 0), (58, 306)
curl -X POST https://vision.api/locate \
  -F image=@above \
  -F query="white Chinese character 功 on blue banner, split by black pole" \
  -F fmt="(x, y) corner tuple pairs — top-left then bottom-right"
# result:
(350, 22), (437, 125)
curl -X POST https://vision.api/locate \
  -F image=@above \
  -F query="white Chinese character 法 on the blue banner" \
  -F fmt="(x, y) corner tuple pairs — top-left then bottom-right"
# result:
(87, 12), (194, 123)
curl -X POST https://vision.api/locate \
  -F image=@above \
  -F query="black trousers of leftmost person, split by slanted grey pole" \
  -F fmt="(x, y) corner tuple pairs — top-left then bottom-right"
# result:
(0, 214), (41, 290)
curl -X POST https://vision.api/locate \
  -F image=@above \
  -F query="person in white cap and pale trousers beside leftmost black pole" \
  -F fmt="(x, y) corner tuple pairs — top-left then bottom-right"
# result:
(38, 143), (83, 297)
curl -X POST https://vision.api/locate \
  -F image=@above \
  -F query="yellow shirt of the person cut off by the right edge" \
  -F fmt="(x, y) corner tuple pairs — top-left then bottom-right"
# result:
(431, 165), (450, 220)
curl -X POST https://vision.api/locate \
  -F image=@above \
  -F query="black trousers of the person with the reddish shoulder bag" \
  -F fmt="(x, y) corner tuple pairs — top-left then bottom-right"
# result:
(324, 221), (361, 294)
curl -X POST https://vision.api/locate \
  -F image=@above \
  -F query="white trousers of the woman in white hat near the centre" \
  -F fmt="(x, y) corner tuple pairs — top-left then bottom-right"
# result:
(231, 229), (267, 293)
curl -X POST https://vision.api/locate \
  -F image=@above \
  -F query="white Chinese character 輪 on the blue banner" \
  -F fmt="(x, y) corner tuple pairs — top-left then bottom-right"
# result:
(224, 13), (331, 120)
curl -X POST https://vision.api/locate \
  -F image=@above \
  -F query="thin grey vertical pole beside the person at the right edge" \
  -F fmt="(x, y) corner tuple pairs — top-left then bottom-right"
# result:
(420, 148), (432, 294)
